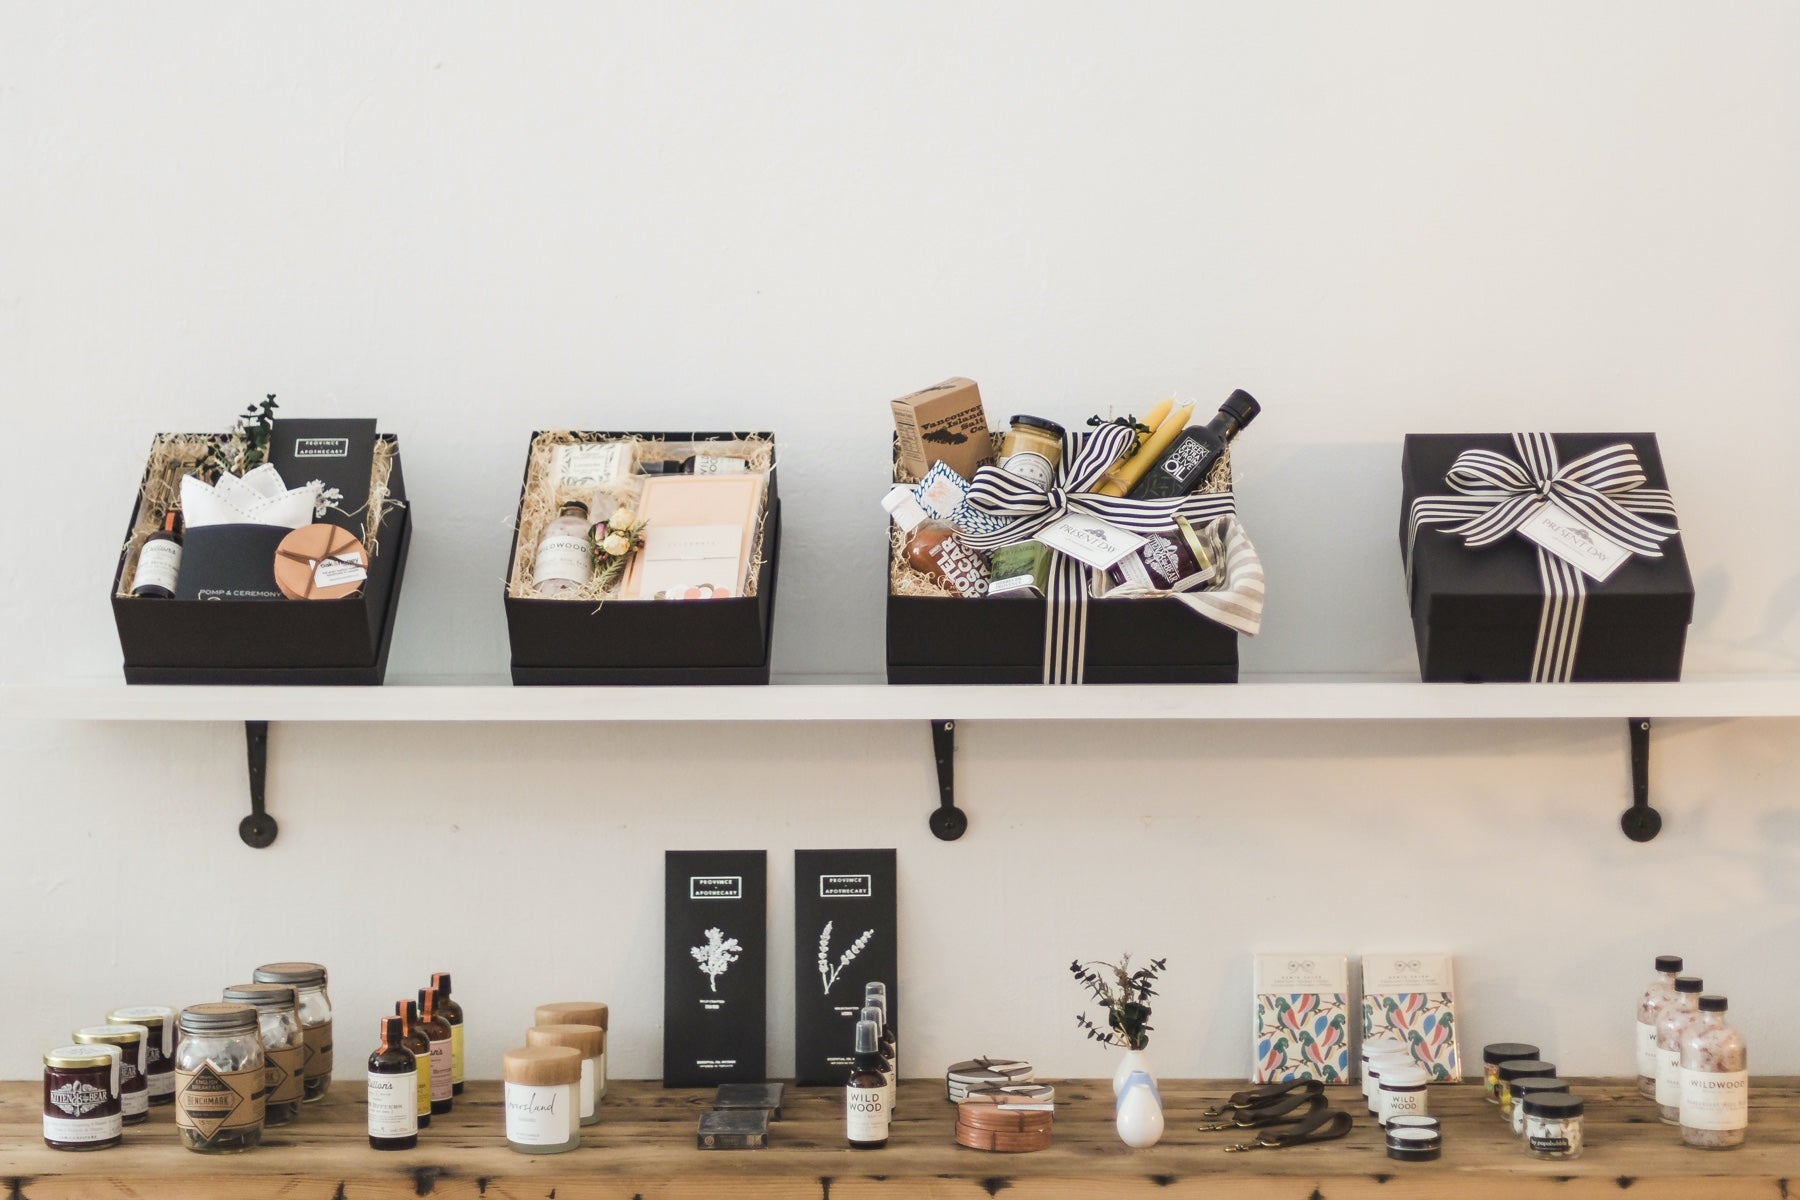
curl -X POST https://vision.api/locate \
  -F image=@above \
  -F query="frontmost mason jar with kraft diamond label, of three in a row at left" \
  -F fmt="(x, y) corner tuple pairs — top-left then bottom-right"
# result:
(175, 1004), (266, 1155)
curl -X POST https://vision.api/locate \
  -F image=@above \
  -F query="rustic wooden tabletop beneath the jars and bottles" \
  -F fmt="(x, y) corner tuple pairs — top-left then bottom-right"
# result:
(0, 1079), (1800, 1200)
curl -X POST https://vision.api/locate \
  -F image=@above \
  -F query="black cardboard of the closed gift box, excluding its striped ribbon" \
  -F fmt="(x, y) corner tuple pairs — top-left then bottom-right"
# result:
(1400, 434), (1694, 684)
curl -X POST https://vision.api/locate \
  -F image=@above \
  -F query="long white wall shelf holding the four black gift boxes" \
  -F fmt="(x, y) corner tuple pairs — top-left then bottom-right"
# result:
(0, 675), (1800, 721)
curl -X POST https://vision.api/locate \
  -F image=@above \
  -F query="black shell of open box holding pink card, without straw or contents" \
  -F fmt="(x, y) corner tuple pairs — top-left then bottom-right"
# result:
(506, 432), (781, 685)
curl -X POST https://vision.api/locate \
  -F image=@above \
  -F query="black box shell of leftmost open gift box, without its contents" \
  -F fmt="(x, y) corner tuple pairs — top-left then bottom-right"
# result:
(112, 431), (412, 684)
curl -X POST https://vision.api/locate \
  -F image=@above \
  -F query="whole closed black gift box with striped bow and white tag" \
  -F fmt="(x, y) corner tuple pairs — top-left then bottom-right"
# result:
(1400, 434), (1694, 684)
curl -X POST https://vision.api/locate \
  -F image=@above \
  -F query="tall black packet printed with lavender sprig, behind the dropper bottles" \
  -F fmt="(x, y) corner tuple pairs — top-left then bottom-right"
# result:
(794, 849), (900, 1087)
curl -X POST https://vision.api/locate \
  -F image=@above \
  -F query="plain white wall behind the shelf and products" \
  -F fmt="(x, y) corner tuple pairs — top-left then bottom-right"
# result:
(0, 0), (1800, 1078)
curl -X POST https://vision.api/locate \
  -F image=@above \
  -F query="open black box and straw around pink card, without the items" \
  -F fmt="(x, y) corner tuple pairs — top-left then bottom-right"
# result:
(504, 430), (781, 685)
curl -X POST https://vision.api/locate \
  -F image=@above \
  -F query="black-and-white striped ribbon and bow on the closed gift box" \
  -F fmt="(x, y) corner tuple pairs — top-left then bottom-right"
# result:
(1406, 434), (1681, 684)
